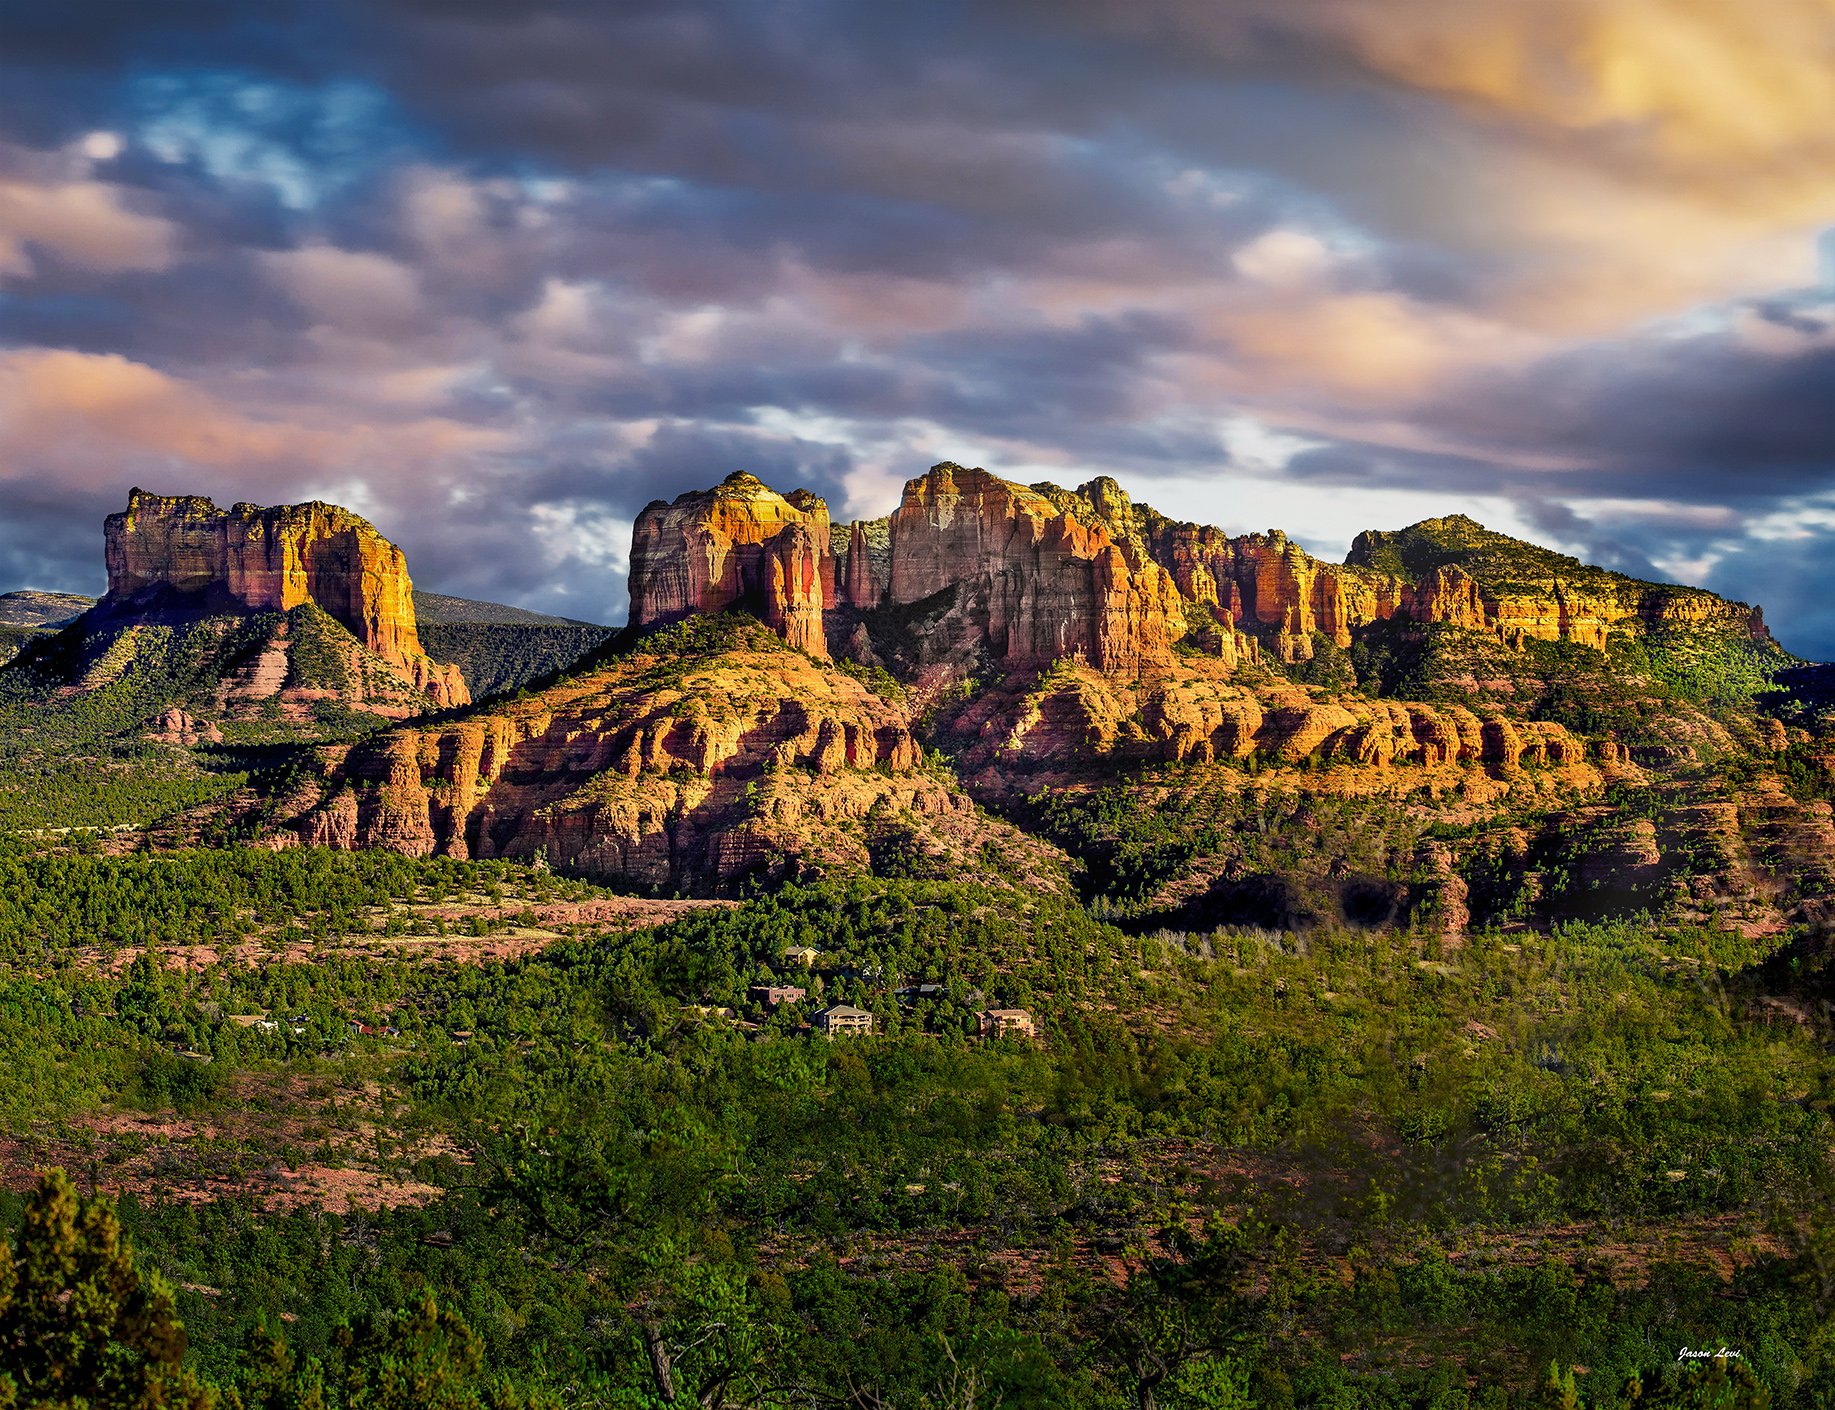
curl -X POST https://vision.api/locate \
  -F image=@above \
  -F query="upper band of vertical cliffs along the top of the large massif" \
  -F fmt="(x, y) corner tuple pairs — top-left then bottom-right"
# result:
(631, 461), (1769, 676)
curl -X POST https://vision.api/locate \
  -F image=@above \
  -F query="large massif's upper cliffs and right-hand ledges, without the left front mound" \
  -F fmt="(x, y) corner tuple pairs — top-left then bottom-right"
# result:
(502, 463), (1789, 914)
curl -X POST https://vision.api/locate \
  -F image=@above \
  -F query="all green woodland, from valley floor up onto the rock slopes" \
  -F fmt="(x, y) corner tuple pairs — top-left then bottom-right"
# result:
(0, 572), (1835, 1410)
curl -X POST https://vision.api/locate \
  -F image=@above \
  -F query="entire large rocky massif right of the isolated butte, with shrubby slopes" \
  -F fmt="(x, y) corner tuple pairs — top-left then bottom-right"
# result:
(50, 463), (1812, 944)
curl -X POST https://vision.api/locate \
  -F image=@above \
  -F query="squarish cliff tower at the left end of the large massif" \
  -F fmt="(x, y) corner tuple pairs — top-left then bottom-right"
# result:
(631, 472), (835, 659)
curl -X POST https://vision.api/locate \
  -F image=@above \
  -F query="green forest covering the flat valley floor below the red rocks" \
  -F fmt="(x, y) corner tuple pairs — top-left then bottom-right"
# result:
(0, 837), (1835, 1406)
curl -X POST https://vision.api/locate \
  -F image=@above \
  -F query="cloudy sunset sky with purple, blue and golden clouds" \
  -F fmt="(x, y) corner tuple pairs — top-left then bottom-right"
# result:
(0, 0), (1835, 659)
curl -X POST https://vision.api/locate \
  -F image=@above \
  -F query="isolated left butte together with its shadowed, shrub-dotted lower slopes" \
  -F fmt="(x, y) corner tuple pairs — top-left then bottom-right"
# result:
(0, 490), (470, 745)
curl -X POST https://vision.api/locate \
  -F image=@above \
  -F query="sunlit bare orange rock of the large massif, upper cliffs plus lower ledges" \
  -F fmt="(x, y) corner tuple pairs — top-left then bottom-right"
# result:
(271, 455), (1763, 892)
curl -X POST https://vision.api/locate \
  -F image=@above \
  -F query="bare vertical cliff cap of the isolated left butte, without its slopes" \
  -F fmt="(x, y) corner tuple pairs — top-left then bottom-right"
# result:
(97, 488), (470, 705)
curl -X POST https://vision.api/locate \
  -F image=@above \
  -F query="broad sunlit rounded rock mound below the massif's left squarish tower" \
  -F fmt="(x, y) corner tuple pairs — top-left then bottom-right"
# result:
(292, 628), (1064, 892)
